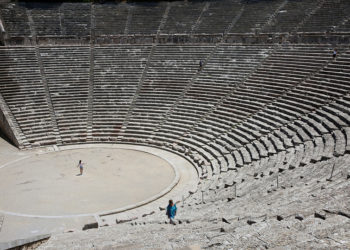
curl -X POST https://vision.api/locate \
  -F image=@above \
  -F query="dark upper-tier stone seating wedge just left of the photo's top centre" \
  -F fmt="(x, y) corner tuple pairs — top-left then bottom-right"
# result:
(128, 1), (167, 34)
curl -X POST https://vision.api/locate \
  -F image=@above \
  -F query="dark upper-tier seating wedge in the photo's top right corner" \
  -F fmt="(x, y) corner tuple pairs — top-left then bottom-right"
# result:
(298, 0), (350, 32)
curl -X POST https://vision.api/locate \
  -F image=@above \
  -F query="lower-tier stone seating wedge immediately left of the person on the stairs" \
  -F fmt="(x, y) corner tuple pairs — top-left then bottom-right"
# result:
(120, 45), (213, 140)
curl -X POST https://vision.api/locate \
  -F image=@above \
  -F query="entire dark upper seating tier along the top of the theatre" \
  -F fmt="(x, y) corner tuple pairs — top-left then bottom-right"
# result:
(0, 0), (350, 38)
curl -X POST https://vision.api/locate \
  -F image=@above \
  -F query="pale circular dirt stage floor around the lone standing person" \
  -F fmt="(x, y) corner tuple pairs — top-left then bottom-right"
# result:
(0, 148), (175, 216)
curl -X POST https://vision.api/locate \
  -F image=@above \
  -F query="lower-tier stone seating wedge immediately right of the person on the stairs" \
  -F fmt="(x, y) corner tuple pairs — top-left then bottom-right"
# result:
(169, 45), (270, 122)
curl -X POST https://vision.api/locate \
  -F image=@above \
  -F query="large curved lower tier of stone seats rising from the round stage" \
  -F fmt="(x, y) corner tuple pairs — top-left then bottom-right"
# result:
(0, 44), (350, 178)
